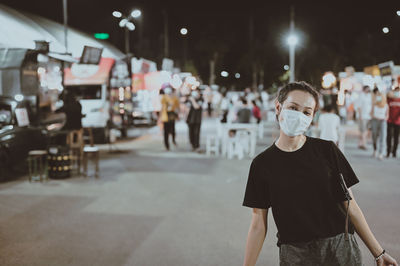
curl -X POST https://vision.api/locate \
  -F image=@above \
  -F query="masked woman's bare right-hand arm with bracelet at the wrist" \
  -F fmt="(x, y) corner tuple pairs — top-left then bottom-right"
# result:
(343, 189), (398, 266)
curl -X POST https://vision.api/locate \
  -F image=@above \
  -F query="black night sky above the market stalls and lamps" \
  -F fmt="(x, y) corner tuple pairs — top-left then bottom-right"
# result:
(0, 0), (400, 88)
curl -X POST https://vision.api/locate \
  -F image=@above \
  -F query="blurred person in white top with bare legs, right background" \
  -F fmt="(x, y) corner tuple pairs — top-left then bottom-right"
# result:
(356, 86), (372, 150)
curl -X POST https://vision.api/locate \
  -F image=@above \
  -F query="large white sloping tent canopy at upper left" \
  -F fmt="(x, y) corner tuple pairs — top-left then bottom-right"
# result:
(0, 4), (124, 59)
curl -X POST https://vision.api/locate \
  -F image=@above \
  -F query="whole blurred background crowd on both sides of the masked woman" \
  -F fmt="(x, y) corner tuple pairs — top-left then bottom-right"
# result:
(159, 83), (400, 160)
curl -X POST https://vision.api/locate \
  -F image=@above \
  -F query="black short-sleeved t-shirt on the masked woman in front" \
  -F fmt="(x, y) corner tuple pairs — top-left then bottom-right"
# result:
(243, 137), (359, 246)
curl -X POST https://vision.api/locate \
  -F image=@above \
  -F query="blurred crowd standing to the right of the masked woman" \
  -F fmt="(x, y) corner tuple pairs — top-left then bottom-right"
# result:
(310, 86), (400, 160)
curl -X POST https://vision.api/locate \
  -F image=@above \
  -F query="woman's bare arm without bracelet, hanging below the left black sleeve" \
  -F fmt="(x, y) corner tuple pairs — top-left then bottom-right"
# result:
(243, 208), (268, 266)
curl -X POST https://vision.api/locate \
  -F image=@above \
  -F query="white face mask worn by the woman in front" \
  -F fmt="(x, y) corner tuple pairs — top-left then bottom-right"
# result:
(279, 109), (312, 137)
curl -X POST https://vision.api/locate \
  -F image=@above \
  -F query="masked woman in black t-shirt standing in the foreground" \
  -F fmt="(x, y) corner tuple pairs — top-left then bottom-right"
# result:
(243, 82), (398, 266)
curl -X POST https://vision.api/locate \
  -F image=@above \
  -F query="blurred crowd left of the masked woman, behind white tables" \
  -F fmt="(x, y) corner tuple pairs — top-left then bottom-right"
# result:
(158, 86), (269, 151)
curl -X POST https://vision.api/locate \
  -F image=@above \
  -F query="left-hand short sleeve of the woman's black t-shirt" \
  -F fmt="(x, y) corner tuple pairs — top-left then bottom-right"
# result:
(243, 161), (271, 209)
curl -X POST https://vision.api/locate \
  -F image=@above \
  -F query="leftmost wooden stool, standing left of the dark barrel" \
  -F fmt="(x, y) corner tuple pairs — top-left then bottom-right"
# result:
(28, 150), (48, 182)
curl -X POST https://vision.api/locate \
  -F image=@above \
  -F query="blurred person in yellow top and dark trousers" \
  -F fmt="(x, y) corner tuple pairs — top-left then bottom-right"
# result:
(160, 87), (179, 150)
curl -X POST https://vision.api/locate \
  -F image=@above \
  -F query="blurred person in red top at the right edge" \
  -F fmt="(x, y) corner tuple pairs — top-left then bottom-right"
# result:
(386, 87), (400, 157)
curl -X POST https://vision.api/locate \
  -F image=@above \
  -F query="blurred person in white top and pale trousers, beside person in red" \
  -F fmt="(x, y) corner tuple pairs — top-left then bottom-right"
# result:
(371, 88), (389, 160)
